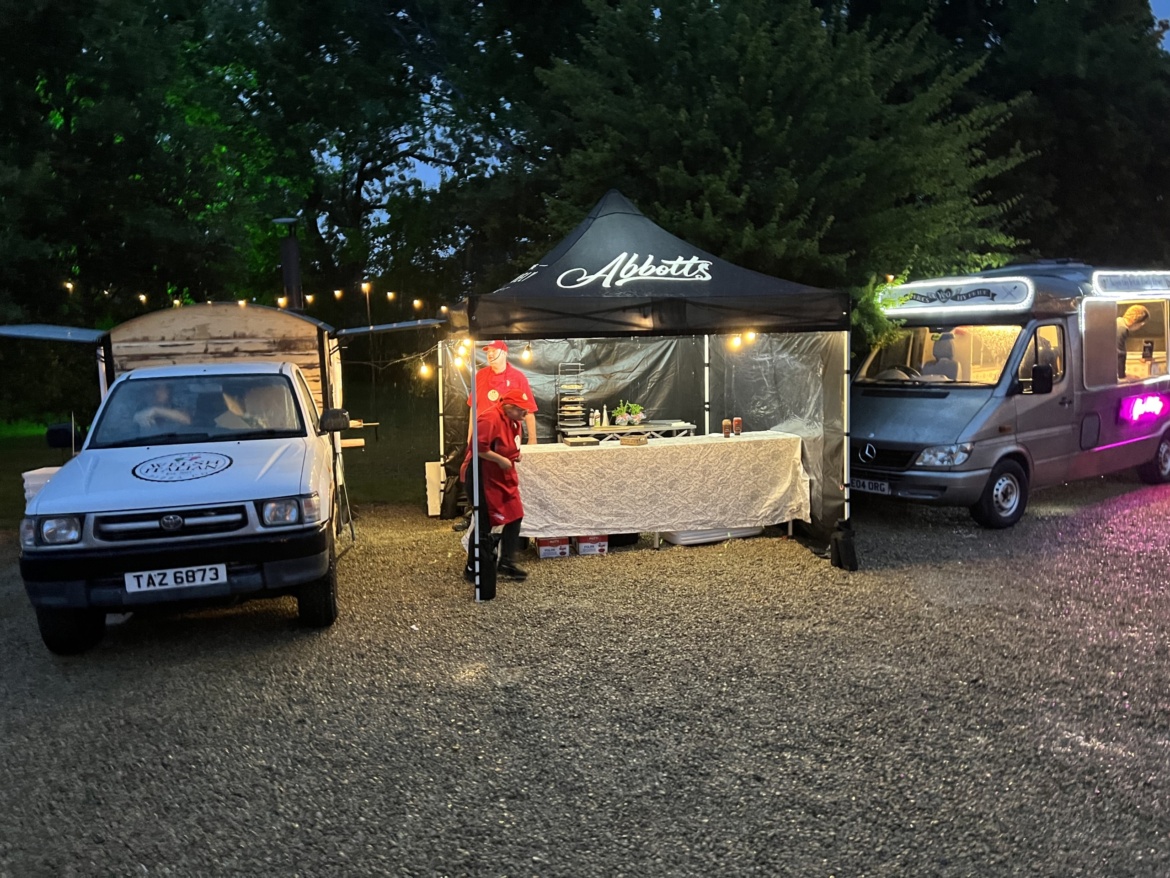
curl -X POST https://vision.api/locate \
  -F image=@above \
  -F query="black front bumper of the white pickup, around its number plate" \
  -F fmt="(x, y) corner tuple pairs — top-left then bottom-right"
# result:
(20, 523), (330, 610)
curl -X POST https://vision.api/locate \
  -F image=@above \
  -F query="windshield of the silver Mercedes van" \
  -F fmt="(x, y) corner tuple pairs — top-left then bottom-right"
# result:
(856, 325), (1021, 386)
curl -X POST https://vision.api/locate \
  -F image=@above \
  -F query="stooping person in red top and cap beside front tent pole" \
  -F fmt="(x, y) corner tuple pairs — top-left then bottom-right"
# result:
(460, 387), (529, 587)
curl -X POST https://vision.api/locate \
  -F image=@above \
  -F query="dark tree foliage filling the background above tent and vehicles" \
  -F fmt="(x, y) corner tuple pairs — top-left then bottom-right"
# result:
(0, 0), (1170, 417)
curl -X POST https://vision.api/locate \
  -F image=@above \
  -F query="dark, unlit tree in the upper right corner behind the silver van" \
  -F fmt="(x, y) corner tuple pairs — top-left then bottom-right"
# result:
(848, 0), (1170, 267)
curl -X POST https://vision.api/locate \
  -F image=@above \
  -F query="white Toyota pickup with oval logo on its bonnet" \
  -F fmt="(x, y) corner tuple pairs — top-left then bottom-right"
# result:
(20, 361), (350, 654)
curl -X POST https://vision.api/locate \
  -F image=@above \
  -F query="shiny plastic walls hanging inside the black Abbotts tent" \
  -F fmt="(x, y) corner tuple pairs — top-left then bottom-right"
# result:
(439, 331), (848, 537)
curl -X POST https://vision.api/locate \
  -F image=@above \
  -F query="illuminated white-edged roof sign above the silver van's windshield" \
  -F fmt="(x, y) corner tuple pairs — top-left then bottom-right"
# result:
(878, 277), (1035, 320)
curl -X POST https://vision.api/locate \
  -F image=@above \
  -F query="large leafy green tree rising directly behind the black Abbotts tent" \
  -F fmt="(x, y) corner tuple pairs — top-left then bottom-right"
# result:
(451, 0), (1016, 302)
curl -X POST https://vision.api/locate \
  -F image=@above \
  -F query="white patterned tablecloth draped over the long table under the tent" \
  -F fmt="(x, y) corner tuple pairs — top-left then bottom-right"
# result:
(517, 431), (810, 536)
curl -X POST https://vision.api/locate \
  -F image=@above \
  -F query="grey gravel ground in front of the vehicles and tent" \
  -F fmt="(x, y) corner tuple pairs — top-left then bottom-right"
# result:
(0, 476), (1170, 878)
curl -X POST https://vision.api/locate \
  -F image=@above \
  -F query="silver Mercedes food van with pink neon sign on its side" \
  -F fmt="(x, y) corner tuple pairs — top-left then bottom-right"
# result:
(849, 262), (1170, 528)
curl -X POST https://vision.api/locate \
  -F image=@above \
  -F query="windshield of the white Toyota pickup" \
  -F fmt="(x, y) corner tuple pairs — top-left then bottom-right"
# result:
(89, 375), (305, 448)
